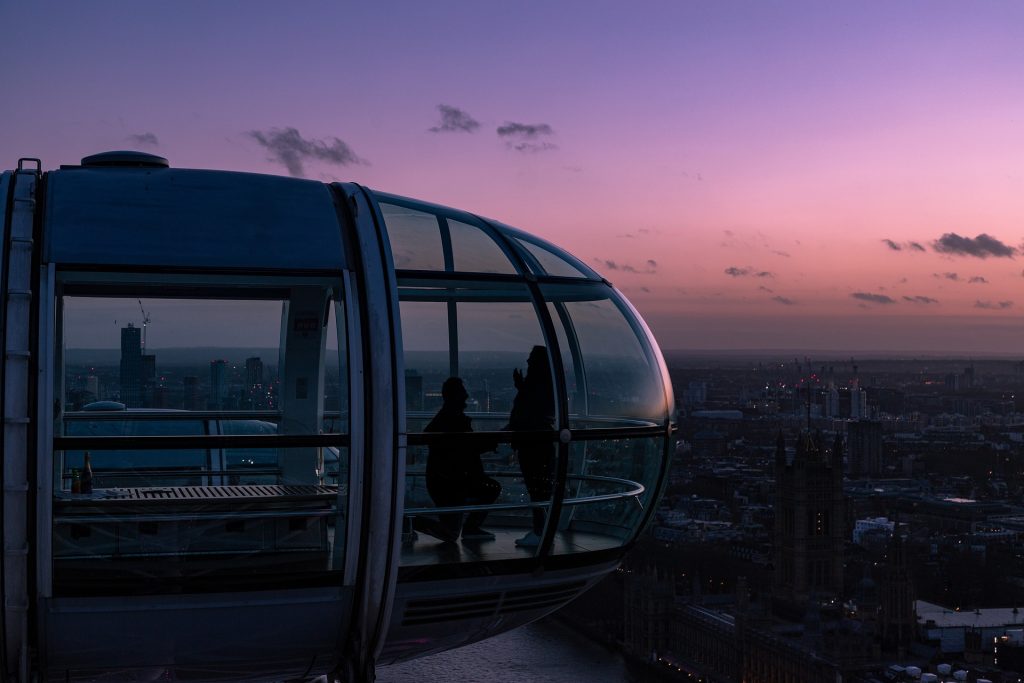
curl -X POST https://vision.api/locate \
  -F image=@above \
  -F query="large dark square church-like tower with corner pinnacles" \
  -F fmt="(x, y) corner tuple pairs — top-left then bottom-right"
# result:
(774, 430), (847, 606)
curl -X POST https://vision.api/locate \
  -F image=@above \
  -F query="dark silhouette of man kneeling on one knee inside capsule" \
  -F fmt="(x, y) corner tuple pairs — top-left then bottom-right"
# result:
(416, 377), (502, 542)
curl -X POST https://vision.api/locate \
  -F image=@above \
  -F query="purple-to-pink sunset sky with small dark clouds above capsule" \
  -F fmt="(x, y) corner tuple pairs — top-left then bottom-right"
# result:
(0, 0), (1024, 356)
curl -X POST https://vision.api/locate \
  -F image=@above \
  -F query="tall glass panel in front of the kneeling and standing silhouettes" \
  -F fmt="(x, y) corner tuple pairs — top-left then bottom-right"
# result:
(398, 279), (557, 566)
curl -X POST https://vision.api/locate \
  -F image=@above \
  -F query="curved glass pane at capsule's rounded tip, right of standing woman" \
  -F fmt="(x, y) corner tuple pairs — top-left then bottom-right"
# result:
(542, 285), (669, 421)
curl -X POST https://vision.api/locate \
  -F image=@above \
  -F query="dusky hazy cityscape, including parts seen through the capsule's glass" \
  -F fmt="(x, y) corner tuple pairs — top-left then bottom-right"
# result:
(59, 326), (1024, 683)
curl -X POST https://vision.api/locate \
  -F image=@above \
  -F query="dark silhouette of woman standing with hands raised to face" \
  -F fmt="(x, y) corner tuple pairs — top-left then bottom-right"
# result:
(506, 346), (555, 547)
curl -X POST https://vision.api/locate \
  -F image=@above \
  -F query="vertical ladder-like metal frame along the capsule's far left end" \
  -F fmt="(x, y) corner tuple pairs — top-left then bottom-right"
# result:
(0, 159), (42, 683)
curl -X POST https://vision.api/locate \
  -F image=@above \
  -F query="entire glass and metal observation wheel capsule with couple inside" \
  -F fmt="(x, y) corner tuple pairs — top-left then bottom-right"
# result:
(0, 153), (673, 681)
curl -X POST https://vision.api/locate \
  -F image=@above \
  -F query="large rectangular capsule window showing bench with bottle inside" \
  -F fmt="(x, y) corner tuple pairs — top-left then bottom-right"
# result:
(51, 272), (349, 596)
